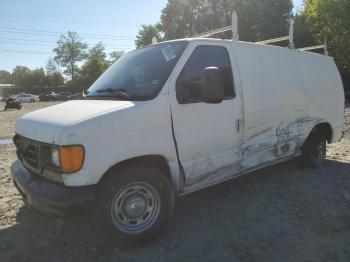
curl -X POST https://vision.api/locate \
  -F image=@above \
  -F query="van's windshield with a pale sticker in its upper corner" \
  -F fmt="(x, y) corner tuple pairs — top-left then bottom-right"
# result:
(87, 41), (188, 100)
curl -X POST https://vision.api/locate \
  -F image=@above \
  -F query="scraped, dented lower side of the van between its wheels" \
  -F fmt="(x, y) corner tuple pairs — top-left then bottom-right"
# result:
(184, 118), (322, 193)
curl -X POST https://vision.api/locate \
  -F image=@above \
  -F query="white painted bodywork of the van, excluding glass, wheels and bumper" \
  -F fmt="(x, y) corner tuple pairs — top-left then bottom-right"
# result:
(16, 39), (344, 194)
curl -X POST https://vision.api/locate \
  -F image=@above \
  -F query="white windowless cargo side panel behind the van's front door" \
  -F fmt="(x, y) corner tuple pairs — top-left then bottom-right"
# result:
(235, 43), (344, 172)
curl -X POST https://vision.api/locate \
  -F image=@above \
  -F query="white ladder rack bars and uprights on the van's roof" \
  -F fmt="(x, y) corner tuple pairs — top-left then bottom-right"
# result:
(189, 10), (328, 56)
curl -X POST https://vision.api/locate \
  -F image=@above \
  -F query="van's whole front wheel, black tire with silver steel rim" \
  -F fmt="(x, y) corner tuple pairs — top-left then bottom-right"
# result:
(97, 166), (175, 243)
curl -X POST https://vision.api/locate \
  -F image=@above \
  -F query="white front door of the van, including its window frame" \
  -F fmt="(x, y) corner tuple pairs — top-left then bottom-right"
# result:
(170, 41), (243, 192)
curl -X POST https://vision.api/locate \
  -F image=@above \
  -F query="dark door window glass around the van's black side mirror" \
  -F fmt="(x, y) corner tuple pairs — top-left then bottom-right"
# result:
(176, 46), (235, 103)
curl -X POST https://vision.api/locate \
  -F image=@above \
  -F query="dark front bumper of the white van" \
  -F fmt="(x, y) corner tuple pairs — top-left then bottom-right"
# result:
(11, 160), (96, 218)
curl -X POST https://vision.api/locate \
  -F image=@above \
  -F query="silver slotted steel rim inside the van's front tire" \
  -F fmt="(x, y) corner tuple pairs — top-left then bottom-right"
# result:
(111, 182), (160, 234)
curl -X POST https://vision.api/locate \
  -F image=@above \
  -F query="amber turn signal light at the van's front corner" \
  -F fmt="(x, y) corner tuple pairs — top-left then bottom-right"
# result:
(59, 145), (85, 173)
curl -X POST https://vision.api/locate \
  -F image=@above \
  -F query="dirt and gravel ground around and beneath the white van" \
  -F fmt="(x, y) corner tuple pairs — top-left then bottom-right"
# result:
(0, 103), (350, 261)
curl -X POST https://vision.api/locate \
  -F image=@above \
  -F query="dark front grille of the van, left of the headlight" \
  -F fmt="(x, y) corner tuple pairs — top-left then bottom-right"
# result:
(14, 135), (41, 173)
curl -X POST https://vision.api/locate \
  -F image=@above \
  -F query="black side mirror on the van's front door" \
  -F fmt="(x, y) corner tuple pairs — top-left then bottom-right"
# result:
(201, 67), (225, 104)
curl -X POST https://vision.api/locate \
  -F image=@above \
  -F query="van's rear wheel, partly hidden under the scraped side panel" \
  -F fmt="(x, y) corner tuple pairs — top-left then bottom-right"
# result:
(301, 133), (327, 168)
